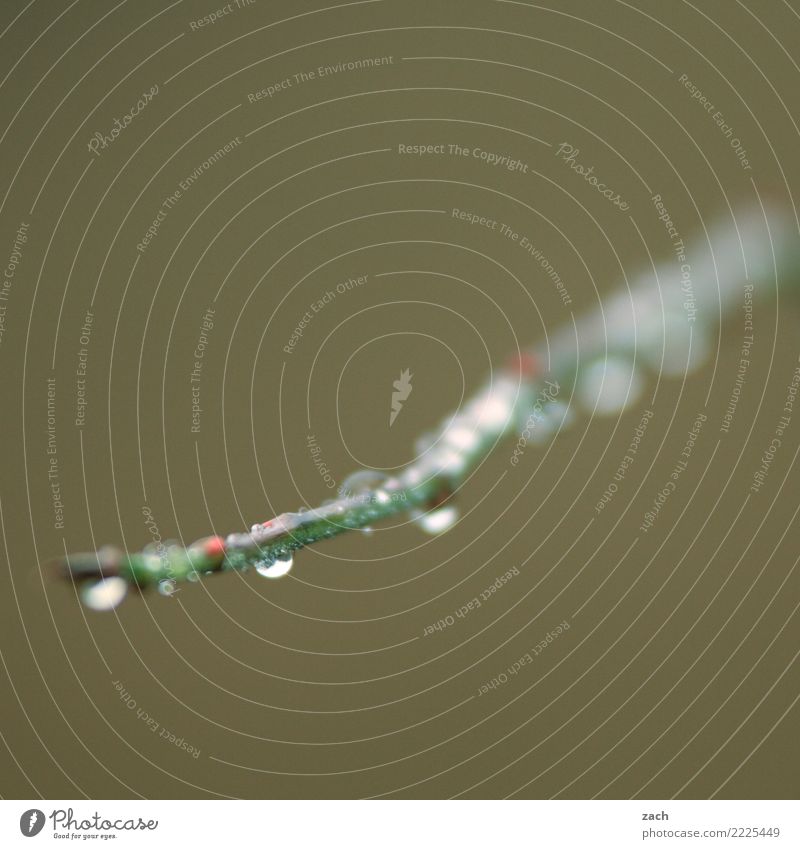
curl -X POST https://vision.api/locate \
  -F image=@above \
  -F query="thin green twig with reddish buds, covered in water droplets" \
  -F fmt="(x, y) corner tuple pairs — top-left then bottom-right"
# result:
(58, 201), (798, 609)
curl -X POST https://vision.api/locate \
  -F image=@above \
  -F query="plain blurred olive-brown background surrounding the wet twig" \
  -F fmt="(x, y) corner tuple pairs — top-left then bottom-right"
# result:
(0, 0), (800, 798)
